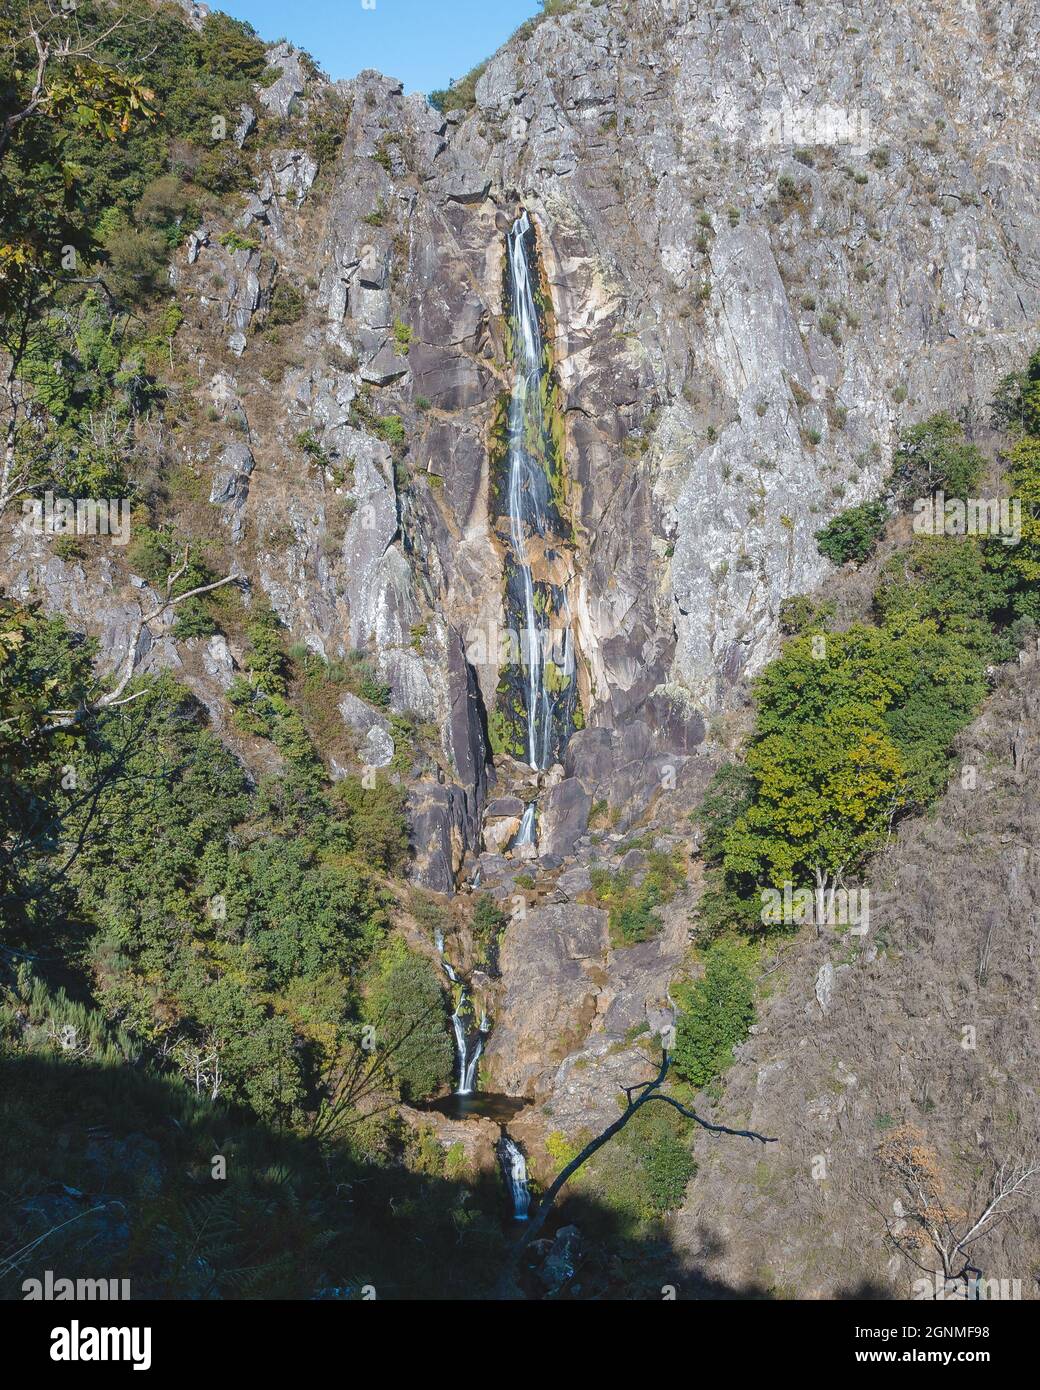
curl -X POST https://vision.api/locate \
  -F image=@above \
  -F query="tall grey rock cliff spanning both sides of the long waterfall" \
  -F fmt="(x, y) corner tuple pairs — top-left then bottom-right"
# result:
(6, 0), (1040, 861)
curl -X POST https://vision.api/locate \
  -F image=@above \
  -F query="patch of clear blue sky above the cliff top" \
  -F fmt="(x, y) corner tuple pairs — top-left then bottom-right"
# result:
(219, 0), (541, 92)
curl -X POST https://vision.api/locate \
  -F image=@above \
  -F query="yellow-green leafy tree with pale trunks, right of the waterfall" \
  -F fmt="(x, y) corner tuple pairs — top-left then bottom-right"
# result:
(722, 612), (987, 920)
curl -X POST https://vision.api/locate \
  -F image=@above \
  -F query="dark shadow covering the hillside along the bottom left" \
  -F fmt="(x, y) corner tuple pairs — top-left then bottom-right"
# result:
(0, 1054), (870, 1300)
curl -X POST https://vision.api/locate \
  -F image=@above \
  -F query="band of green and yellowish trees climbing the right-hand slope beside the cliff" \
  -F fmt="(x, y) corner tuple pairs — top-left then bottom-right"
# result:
(689, 369), (1040, 935)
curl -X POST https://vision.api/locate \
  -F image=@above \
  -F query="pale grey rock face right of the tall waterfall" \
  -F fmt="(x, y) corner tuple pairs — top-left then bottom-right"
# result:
(448, 0), (1040, 724)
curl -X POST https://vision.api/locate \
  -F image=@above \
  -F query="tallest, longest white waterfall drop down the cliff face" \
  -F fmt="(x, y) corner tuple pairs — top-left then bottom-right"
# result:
(507, 213), (574, 772)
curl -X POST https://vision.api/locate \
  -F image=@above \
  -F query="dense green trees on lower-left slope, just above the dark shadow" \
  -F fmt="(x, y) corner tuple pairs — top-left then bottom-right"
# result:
(0, 594), (433, 1123)
